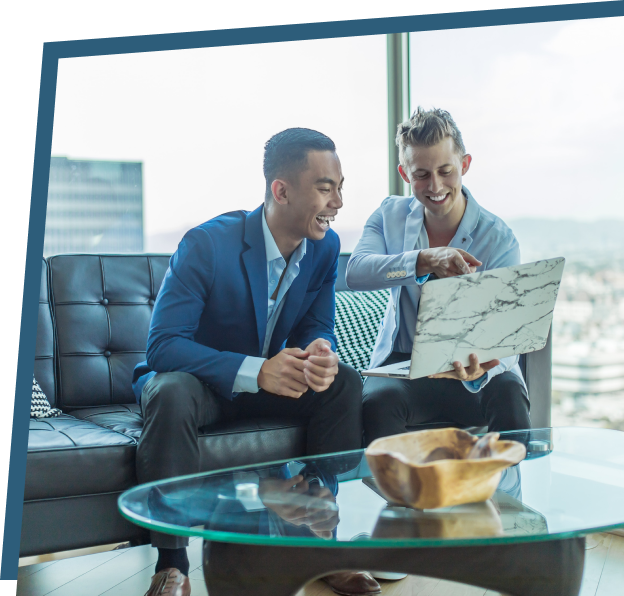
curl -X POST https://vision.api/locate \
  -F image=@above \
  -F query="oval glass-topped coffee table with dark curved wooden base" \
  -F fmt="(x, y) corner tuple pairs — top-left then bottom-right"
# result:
(119, 428), (624, 596)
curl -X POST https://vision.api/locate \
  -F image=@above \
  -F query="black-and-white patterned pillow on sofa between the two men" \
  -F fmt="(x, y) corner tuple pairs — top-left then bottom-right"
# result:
(335, 290), (390, 371)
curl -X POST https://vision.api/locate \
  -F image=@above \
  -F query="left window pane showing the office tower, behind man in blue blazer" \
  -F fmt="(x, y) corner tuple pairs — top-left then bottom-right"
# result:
(50, 35), (388, 255)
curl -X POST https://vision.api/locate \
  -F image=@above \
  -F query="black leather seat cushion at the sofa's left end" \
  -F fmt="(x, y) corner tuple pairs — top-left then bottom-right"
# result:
(24, 414), (137, 501)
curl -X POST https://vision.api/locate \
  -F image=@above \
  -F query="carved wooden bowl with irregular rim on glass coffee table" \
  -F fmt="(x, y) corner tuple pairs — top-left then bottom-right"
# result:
(365, 428), (526, 509)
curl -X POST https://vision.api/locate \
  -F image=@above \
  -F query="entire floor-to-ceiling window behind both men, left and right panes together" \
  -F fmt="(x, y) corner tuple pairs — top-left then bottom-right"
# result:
(44, 17), (624, 428)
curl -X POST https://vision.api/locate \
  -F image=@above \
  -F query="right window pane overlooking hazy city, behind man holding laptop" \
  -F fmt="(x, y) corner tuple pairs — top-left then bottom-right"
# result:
(410, 17), (624, 430)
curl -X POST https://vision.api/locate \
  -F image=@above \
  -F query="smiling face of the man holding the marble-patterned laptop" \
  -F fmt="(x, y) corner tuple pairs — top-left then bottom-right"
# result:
(399, 137), (472, 225)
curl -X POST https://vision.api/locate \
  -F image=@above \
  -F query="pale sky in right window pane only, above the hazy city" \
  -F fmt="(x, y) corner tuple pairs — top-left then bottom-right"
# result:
(410, 17), (624, 226)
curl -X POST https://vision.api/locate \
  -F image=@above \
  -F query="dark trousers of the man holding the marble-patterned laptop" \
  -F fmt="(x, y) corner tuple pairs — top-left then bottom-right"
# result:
(362, 352), (531, 445)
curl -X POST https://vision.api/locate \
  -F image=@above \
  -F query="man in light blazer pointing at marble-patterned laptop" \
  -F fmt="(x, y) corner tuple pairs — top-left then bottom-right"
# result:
(346, 107), (531, 444)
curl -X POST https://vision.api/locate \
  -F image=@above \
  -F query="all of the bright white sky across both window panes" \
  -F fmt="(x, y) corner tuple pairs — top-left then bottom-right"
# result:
(52, 17), (624, 250)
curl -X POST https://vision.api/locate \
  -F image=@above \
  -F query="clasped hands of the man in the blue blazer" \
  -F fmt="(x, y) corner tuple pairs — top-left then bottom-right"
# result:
(258, 338), (338, 399)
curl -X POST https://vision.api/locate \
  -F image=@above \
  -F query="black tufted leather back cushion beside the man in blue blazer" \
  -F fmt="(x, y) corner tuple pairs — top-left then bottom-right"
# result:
(49, 255), (169, 412)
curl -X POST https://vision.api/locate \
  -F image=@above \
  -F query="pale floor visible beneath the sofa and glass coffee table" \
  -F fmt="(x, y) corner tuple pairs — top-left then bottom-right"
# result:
(16, 534), (624, 596)
